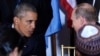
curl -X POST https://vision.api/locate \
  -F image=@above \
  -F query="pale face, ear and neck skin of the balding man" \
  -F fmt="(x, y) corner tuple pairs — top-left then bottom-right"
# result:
(71, 6), (96, 32)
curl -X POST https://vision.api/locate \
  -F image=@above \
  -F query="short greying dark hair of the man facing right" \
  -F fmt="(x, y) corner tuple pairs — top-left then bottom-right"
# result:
(14, 3), (37, 17)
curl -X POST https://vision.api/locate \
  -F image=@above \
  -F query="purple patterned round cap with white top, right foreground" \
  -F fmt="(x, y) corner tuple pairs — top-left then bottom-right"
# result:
(75, 24), (100, 56)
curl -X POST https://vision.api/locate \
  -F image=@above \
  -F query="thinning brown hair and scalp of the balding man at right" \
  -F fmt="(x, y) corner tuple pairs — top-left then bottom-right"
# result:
(75, 3), (98, 22)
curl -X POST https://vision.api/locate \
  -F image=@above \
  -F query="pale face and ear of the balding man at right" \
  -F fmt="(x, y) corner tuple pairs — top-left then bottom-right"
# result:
(71, 9), (85, 32)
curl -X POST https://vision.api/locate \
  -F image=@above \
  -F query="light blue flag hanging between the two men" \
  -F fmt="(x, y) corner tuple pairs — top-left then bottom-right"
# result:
(45, 0), (62, 46)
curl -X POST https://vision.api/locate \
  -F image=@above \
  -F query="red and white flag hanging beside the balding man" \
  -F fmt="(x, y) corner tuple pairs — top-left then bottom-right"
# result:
(60, 0), (76, 27)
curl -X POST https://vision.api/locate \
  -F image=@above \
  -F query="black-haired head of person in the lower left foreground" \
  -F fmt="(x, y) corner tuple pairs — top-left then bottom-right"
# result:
(0, 25), (27, 56)
